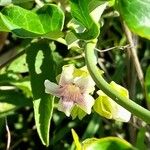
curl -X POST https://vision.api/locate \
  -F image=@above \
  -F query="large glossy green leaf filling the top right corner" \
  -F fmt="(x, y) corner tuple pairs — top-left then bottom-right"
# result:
(116, 0), (150, 39)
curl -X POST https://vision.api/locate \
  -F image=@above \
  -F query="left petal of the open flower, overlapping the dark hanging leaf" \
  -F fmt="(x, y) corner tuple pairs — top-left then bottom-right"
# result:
(44, 80), (59, 97)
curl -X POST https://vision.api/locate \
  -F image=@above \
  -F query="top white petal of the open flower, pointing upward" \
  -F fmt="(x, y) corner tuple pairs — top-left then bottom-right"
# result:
(59, 64), (75, 85)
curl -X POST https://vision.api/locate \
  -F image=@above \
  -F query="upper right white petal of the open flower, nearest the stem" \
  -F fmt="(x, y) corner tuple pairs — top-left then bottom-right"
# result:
(74, 75), (95, 93)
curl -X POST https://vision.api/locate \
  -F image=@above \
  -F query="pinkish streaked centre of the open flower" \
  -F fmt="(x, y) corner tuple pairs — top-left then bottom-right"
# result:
(60, 84), (82, 102)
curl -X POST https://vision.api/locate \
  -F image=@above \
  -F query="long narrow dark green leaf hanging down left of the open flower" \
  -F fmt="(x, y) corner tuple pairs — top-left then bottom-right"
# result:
(27, 41), (55, 146)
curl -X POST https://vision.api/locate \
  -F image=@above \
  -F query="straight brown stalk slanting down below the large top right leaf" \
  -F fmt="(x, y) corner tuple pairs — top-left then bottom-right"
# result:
(123, 22), (144, 88)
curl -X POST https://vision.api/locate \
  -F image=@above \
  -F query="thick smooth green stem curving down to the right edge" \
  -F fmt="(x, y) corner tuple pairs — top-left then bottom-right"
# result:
(85, 42), (150, 124)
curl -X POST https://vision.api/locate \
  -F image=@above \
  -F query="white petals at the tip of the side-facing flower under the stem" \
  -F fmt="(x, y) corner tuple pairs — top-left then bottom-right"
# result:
(113, 103), (131, 122)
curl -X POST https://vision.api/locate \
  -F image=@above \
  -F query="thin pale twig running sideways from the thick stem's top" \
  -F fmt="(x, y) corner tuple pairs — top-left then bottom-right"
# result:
(95, 44), (131, 53)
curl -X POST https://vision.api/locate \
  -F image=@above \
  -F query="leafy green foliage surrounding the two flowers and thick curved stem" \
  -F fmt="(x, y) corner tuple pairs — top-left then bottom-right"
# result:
(0, 0), (150, 150)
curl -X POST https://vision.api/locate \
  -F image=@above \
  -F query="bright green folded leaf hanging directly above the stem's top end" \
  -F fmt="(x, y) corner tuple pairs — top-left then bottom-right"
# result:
(70, 0), (99, 40)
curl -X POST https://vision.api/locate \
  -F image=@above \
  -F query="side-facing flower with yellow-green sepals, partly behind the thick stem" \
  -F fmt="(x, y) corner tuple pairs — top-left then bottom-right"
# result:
(93, 81), (131, 122)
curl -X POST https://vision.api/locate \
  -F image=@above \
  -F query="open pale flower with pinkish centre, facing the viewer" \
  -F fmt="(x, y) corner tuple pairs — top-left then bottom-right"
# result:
(44, 64), (95, 116)
